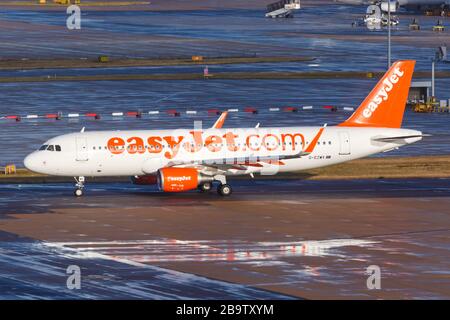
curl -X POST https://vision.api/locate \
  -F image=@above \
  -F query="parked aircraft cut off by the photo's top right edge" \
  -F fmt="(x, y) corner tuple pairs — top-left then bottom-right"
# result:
(335, 0), (450, 12)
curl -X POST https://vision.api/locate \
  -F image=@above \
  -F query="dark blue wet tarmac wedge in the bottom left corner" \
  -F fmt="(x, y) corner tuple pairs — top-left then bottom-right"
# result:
(0, 233), (293, 300)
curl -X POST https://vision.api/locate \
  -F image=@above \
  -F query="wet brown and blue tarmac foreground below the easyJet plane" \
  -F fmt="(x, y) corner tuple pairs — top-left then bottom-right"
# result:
(0, 179), (450, 299)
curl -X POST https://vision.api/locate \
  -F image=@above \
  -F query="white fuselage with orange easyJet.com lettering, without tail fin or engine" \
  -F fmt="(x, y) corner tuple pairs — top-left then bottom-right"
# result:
(24, 126), (421, 177)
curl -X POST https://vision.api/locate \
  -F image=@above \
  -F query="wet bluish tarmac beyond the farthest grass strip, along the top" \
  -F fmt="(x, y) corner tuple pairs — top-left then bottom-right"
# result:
(0, 3), (448, 70)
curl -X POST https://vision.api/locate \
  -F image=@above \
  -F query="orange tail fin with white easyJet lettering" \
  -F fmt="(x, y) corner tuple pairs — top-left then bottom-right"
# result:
(339, 60), (416, 128)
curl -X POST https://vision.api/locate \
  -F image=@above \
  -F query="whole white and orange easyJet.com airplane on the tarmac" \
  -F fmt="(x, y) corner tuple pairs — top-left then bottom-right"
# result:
(24, 61), (422, 196)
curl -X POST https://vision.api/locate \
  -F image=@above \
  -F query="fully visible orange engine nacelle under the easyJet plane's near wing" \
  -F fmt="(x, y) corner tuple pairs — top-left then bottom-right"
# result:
(158, 168), (202, 192)
